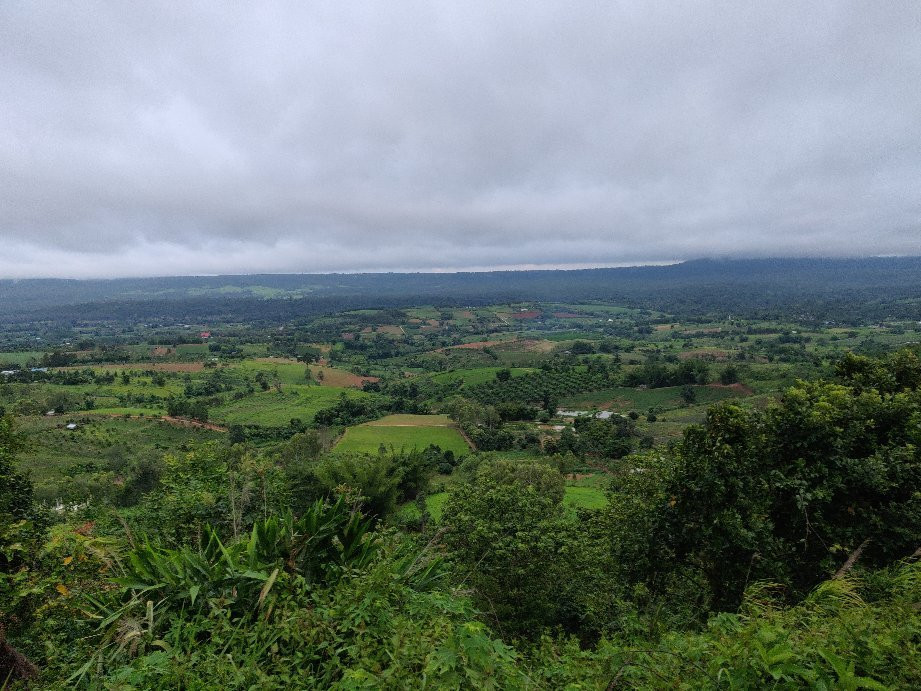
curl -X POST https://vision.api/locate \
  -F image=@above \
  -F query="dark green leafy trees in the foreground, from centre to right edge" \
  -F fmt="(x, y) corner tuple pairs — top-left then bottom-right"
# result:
(444, 351), (921, 638)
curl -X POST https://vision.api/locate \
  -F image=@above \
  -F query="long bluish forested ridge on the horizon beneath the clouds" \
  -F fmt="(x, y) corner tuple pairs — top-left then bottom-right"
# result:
(0, 257), (921, 321)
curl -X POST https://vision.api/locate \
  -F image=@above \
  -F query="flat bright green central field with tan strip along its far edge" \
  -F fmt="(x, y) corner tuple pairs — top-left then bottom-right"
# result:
(335, 415), (470, 456)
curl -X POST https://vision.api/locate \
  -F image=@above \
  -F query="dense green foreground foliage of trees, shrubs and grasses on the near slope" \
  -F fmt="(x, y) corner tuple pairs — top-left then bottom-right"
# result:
(0, 350), (921, 689)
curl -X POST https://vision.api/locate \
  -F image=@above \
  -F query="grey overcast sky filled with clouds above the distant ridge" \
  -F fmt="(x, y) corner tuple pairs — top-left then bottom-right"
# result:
(0, 0), (921, 277)
